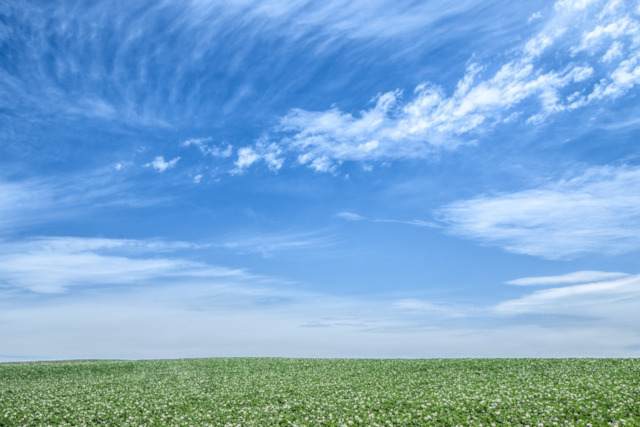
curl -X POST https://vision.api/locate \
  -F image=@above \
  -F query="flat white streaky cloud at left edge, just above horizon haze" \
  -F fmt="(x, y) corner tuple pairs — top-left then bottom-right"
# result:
(0, 237), (250, 293)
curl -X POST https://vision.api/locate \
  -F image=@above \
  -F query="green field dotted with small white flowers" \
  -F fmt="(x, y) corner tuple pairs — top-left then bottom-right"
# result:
(0, 358), (640, 426)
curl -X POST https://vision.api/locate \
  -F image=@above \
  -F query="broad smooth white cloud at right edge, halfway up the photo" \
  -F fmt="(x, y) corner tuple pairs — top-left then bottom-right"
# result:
(435, 166), (640, 259)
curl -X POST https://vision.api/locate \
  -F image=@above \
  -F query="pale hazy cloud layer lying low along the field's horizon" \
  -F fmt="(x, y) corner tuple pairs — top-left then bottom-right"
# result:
(0, 284), (640, 360)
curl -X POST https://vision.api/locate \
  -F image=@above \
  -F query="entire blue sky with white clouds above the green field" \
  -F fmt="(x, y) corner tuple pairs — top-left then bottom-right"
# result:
(0, 0), (640, 361)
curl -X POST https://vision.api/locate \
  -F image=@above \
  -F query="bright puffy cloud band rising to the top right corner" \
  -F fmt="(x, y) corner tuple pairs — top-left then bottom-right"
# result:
(235, 0), (640, 172)
